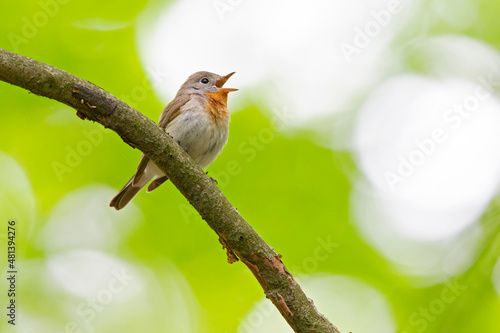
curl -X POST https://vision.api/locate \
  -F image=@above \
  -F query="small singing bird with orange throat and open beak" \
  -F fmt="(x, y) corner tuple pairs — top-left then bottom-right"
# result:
(109, 72), (238, 210)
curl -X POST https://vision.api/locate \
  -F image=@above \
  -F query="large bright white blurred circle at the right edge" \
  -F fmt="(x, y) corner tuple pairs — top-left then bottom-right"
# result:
(354, 75), (500, 239)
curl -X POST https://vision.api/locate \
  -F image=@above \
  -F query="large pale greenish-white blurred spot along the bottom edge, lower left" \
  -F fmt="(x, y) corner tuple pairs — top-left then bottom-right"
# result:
(12, 250), (202, 333)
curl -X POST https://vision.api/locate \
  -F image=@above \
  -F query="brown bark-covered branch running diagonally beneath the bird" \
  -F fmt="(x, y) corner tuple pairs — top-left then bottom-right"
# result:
(0, 49), (340, 333)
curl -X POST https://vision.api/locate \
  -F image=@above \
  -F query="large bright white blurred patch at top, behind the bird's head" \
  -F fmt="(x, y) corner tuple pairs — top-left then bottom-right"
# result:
(137, 0), (413, 124)
